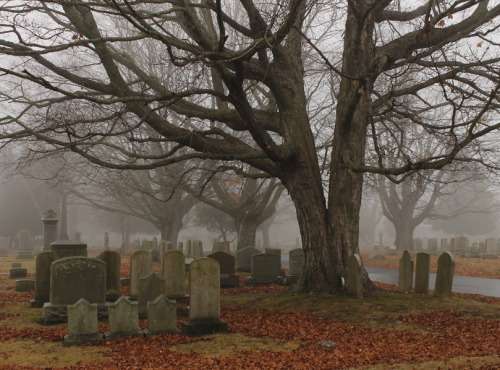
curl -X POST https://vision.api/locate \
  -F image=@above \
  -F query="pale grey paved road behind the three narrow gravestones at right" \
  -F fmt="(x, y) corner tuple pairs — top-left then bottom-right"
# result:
(366, 267), (500, 297)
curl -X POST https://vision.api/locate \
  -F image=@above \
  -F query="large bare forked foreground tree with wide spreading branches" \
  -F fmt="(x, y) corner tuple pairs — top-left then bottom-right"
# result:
(0, 0), (500, 292)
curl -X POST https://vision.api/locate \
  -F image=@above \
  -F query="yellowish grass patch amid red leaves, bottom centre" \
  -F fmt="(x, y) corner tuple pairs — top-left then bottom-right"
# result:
(170, 333), (299, 357)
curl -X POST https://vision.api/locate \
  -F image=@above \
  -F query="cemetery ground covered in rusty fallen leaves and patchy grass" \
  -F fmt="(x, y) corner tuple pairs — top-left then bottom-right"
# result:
(0, 255), (500, 369)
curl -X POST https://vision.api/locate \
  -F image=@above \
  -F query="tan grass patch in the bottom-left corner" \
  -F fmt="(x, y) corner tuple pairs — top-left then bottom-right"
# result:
(0, 339), (108, 368)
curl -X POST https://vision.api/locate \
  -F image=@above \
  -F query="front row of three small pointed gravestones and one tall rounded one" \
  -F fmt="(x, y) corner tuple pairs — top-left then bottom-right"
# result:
(64, 257), (227, 345)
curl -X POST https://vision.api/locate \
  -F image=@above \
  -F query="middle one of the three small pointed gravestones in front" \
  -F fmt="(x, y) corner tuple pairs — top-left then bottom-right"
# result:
(104, 297), (143, 340)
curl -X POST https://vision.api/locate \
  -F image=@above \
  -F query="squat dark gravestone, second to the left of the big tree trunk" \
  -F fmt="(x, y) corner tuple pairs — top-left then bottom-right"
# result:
(245, 253), (281, 286)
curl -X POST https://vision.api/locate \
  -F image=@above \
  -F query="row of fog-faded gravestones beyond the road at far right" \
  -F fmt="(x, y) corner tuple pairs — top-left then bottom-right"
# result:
(413, 235), (500, 258)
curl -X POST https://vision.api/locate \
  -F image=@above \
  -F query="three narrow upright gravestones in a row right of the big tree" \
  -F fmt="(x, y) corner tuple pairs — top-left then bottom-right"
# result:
(398, 250), (455, 297)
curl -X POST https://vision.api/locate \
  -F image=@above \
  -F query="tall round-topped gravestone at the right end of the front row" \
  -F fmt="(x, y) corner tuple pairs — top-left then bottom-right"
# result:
(181, 257), (227, 335)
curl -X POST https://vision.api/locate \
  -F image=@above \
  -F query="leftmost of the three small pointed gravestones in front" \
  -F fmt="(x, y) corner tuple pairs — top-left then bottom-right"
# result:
(64, 298), (103, 346)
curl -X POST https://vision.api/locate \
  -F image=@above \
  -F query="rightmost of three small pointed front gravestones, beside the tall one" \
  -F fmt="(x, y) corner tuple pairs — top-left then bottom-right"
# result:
(143, 295), (180, 337)
